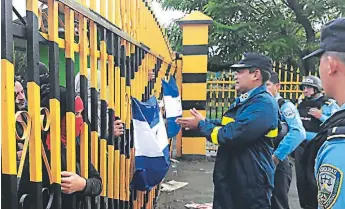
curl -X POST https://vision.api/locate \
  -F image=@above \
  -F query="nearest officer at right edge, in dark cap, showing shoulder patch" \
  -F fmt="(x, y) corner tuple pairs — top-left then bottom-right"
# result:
(304, 18), (345, 209)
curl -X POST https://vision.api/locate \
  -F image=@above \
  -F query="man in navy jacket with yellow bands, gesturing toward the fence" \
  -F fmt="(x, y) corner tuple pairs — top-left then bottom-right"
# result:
(177, 53), (279, 209)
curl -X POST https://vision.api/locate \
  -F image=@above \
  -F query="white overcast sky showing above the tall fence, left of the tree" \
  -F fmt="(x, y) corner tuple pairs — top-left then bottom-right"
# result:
(12, 0), (184, 26)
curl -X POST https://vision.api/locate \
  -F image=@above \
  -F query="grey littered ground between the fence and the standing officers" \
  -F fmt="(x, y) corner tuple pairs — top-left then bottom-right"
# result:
(156, 157), (301, 209)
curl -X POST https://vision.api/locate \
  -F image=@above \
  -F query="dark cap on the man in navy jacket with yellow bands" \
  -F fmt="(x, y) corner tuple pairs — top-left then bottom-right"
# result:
(231, 52), (272, 71)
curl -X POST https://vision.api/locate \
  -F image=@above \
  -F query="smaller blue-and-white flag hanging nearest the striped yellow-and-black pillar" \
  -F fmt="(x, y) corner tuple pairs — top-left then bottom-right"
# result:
(162, 77), (182, 138)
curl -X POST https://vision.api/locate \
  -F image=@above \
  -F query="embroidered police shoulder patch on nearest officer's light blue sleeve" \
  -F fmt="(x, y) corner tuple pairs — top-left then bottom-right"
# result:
(316, 164), (343, 209)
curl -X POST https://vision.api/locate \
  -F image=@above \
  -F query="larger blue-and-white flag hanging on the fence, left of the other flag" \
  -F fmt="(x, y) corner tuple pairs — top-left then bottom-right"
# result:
(131, 97), (170, 191)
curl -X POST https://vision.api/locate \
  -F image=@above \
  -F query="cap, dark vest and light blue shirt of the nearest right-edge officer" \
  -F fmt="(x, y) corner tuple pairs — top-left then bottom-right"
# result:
(303, 18), (345, 209)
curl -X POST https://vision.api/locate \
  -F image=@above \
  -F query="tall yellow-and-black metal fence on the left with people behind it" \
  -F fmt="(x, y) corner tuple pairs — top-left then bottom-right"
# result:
(1, 0), (181, 209)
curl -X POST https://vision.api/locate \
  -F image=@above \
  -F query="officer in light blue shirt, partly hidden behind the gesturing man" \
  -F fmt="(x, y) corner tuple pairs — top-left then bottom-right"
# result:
(266, 72), (305, 209)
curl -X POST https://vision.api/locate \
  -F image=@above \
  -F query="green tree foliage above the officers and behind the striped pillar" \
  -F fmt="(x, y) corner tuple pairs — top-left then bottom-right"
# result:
(159, 0), (345, 72)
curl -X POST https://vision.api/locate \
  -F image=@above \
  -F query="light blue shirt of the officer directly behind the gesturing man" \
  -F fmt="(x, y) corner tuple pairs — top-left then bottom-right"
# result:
(273, 94), (306, 161)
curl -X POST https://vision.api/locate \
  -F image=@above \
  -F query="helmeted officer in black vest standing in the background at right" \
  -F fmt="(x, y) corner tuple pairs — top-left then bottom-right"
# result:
(295, 76), (339, 208)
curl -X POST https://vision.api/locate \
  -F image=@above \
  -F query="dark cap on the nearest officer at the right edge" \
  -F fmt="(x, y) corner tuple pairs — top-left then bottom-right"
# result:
(303, 17), (345, 60)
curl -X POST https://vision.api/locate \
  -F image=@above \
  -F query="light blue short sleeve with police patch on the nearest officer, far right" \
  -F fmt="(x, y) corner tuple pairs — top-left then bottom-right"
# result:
(315, 104), (345, 209)
